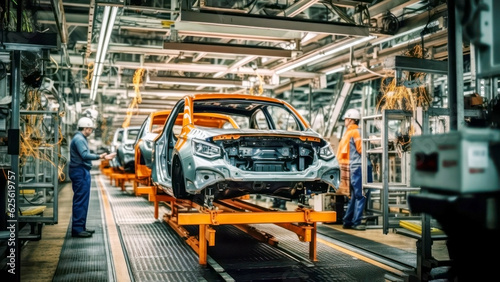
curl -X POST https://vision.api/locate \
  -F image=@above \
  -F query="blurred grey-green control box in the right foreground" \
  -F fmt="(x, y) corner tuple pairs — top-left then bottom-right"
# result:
(411, 128), (500, 194)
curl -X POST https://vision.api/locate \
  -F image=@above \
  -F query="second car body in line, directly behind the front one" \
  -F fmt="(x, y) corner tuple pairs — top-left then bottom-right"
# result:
(134, 110), (170, 185)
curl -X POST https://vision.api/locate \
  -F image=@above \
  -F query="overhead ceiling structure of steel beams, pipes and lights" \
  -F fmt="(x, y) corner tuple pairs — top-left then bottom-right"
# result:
(32, 0), (447, 134)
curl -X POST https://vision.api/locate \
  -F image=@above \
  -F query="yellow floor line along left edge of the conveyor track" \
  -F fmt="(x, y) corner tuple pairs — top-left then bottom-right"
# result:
(99, 177), (131, 282)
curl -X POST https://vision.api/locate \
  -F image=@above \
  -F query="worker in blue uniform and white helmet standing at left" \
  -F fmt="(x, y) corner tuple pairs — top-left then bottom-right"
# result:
(69, 117), (113, 238)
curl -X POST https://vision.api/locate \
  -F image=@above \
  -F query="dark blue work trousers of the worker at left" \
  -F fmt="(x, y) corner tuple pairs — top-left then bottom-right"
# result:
(69, 167), (91, 235)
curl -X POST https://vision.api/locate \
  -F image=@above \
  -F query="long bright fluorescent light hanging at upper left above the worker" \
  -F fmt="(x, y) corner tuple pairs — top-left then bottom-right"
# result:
(90, 6), (118, 101)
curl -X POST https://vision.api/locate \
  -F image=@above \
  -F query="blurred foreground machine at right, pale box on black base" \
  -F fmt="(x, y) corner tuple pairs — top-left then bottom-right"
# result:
(408, 128), (500, 281)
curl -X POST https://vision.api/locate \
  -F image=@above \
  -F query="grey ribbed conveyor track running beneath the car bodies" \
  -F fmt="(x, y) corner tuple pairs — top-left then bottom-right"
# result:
(83, 176), (414, 281)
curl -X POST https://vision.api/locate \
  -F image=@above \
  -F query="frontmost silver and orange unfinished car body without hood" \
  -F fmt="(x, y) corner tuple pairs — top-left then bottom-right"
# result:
(151, 94), (340, 207)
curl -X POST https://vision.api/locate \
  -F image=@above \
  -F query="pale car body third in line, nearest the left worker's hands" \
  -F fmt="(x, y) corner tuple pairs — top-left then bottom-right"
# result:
(115, 126), (140, 173)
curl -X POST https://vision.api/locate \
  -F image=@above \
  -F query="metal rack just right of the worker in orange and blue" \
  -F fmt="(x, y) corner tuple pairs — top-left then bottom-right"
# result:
(361, 110), (420, 234)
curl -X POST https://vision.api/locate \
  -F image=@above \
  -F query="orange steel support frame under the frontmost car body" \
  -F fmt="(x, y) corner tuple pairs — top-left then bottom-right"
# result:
(150, 192), (337, 265)
